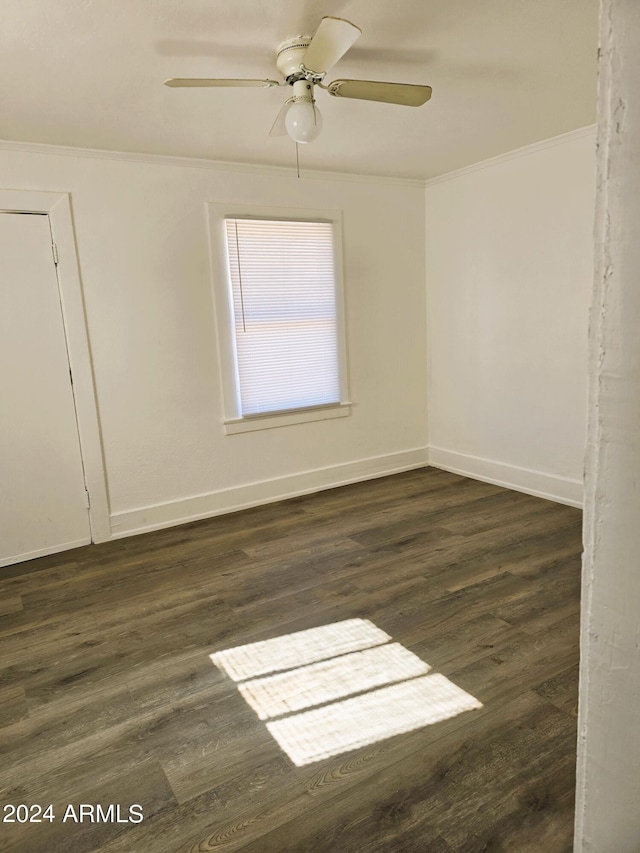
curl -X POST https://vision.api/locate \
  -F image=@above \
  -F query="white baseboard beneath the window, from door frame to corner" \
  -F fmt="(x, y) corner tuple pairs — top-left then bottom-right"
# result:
(111, 447), (427, 539)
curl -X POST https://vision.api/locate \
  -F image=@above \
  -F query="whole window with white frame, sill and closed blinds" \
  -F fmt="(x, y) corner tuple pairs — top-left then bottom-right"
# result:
(212, 205), (349, 432)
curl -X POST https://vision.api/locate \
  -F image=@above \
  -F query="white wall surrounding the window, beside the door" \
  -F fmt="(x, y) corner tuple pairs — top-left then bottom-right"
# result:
(0, 140), (426, 535)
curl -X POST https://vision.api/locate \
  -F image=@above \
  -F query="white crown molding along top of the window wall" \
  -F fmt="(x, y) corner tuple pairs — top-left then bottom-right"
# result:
(0, 139), (424, 188)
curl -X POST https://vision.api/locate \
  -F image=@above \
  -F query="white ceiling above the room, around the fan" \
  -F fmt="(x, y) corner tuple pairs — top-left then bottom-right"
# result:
(0, 0), (598, 178)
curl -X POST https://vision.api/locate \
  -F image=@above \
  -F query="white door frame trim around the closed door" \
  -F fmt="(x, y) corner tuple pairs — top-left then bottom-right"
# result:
(0, 189), (111, 542)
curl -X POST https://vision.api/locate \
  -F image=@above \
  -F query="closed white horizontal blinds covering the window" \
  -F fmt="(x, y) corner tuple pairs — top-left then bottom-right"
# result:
(225, 218), (340, 417)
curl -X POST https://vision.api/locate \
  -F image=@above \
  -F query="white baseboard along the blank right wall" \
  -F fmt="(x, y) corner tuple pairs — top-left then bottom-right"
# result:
(427, 447), (583, 509)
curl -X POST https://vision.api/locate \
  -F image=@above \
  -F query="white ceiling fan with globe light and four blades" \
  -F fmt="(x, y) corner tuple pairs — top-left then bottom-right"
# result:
(165, 17), (431, 142)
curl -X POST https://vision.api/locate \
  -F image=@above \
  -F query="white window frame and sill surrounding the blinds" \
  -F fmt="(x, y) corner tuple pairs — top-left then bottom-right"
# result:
(207, 202), (351, 435)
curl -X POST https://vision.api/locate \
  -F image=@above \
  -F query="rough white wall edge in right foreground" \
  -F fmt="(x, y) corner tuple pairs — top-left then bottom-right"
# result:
(574, 0), (640, 853)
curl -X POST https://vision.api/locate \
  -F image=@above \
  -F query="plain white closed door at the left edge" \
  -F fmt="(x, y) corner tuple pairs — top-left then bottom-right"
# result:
(0, 213), (91, 566)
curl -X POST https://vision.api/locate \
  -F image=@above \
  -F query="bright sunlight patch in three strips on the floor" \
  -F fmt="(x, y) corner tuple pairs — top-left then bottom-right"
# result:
(210, 619), (482, 767)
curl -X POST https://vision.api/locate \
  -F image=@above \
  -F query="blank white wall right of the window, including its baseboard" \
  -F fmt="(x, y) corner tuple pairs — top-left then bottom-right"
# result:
(426, 129), (595, 505)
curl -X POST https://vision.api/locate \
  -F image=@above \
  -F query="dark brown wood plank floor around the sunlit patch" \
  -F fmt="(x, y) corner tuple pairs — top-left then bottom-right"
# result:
(0, 468), (581, 853)
